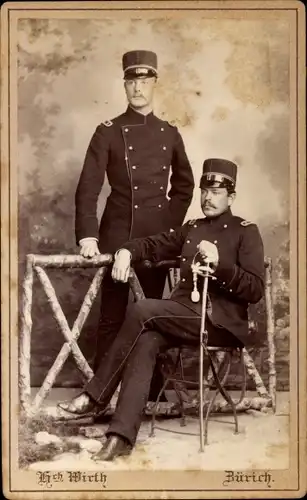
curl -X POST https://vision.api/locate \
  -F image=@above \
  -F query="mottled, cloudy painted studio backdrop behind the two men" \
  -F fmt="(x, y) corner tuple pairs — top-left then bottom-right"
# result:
(18, 14), (289, 389)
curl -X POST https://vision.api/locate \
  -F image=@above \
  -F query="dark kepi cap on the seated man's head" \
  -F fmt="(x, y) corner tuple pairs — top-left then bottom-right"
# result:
(199, 158), (237, 190)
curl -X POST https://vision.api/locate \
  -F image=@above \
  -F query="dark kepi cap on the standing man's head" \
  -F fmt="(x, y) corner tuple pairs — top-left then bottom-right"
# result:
(122, 50), (158, 79)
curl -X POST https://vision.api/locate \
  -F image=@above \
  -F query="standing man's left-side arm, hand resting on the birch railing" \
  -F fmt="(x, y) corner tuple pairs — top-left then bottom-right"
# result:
(75, 125), (109, 257)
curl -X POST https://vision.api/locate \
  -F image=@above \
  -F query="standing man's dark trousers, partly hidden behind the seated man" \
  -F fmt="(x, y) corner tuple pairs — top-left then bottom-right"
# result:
(94, 268), (167, 400)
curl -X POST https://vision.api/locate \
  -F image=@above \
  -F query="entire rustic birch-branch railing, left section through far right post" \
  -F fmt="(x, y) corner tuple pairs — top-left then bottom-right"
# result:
(19, 254), (276, 417)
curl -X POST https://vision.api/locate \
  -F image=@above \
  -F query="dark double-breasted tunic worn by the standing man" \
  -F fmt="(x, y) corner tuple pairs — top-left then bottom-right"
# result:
(76, 107), (194, 252)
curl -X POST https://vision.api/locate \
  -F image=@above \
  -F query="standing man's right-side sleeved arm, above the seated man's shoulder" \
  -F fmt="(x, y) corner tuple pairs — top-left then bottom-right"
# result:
(168, 128), (194, 225)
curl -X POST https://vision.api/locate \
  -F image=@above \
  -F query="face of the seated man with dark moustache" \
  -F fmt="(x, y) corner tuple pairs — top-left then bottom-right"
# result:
(201, 187), (235, 218)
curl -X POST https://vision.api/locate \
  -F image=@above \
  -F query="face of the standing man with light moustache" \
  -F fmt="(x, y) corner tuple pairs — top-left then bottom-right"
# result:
(125, 77), (156, 109)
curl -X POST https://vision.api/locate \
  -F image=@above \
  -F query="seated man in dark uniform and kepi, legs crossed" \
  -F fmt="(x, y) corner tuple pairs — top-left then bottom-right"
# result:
(59, 159), (264, 460)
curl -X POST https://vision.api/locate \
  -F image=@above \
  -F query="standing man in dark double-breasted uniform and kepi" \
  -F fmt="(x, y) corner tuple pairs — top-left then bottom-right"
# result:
(76, 50), (194, 397)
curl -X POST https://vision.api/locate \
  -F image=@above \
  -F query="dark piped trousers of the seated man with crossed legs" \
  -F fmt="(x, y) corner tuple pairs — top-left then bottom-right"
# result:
(85, 299), (242, 445)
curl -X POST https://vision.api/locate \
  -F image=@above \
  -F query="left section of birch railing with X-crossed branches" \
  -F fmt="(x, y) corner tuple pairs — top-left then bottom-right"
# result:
(19, 254), (113, 415)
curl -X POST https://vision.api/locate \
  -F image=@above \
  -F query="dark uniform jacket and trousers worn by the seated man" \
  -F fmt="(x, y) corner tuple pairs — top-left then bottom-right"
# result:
(85, 209), (264, 444)
